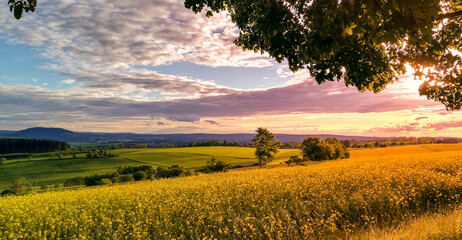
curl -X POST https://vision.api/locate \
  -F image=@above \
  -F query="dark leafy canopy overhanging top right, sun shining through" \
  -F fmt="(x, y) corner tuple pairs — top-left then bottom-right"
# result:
(185, 0), (462, 110)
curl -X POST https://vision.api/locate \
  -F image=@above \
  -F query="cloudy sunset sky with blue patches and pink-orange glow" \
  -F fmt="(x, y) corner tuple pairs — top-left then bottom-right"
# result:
(0, 0), (462, 137)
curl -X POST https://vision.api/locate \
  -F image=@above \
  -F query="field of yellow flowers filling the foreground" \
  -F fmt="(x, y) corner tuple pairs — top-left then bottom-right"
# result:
(0, 145), (462, 239)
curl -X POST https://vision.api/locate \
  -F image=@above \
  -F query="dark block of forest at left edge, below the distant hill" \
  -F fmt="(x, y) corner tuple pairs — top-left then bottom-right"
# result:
(0, 138), (71, 154)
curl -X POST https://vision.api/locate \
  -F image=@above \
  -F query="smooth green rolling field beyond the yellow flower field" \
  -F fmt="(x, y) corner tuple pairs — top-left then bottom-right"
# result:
(0, 147), (299, 191)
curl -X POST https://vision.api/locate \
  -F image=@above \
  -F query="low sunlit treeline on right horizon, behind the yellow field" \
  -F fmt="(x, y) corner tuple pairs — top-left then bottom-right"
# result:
(340, 137), (459, 148)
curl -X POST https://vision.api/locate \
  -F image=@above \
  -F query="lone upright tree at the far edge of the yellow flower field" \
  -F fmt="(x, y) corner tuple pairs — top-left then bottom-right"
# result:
(252, 128), (282, 167)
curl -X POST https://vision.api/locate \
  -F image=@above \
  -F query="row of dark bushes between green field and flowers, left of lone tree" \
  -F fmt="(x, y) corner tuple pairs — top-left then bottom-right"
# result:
(64, 165), (195, 187)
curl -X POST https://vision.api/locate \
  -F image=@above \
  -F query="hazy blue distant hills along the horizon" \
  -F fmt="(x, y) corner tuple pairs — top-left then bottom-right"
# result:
(0, 127), (390, 144)
